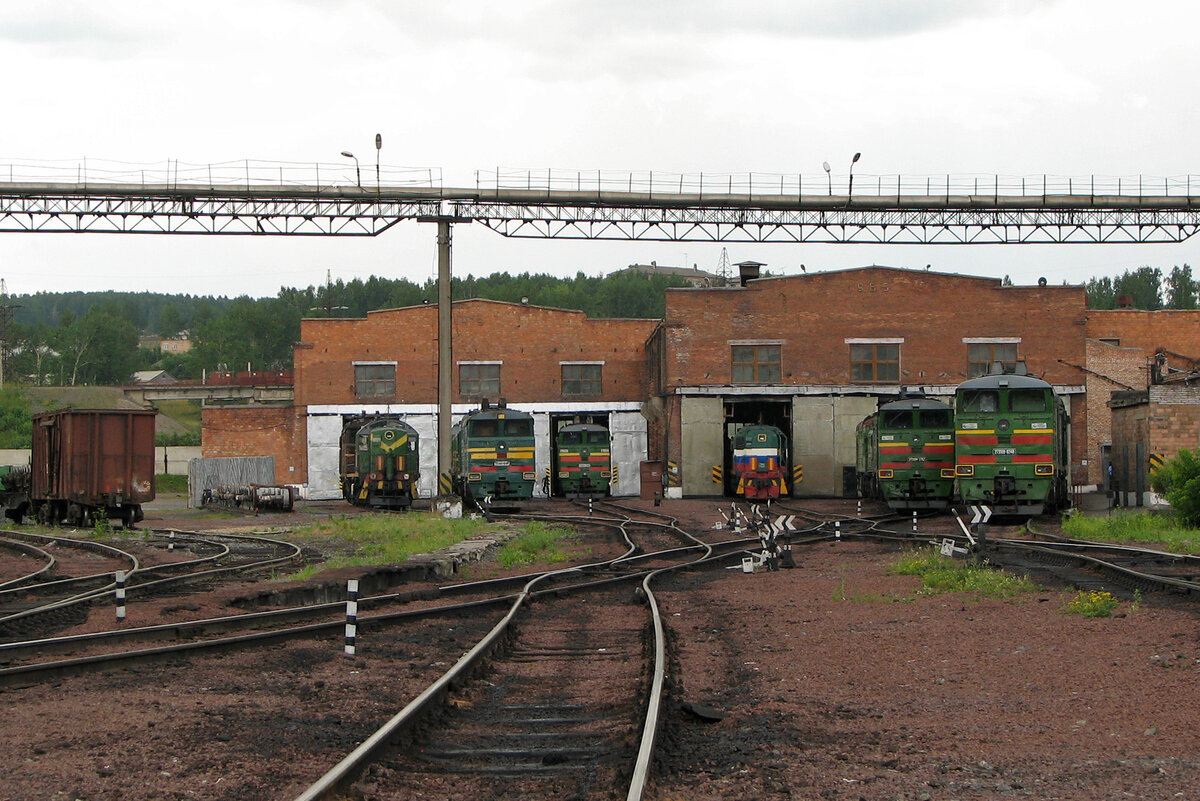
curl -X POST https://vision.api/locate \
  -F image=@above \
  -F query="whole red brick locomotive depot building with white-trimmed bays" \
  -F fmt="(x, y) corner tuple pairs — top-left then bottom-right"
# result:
(204, 263), (1200, 498)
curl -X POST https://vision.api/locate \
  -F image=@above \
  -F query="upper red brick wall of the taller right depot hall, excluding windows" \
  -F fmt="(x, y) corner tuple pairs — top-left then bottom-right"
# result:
(665, 267), (1086, 387)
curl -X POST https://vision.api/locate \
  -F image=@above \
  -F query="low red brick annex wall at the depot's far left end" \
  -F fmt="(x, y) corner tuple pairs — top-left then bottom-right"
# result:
(200, 406), (308, 484)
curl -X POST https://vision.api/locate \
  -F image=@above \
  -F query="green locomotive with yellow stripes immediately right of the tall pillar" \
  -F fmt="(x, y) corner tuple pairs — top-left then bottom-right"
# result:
(450, 401), (538, 501)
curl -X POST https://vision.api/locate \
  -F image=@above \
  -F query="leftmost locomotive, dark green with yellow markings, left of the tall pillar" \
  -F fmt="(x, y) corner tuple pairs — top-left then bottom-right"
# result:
(341, 416), (421, 510)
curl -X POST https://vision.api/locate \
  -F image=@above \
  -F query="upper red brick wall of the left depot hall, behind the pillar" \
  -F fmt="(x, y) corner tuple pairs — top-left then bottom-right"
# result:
(295, 300), (658, 406)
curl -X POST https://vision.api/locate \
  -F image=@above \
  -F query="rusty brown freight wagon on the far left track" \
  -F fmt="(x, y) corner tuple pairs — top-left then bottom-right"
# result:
(30, 409), (155, 528)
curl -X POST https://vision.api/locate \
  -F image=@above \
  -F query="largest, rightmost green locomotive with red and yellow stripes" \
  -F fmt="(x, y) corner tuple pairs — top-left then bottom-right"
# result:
(954, 365), (1070, 514)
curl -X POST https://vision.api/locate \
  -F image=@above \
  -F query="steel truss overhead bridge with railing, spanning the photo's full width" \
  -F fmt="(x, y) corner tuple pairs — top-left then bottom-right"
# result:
(0, 173), (1200, 245)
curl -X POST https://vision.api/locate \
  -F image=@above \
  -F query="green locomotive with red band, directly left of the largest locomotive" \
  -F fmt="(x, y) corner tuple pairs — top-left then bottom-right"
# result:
(854, 397), (954, 510)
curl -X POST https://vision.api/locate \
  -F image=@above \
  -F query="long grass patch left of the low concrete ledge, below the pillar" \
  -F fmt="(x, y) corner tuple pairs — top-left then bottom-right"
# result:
(282, 513), (494, 580)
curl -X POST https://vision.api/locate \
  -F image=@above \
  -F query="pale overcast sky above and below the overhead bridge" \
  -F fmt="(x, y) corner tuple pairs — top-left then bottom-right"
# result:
(0, 0), (1200, 296)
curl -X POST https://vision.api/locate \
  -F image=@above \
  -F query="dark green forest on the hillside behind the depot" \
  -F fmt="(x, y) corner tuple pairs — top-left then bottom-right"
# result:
(0, 264), (1200, 389)
